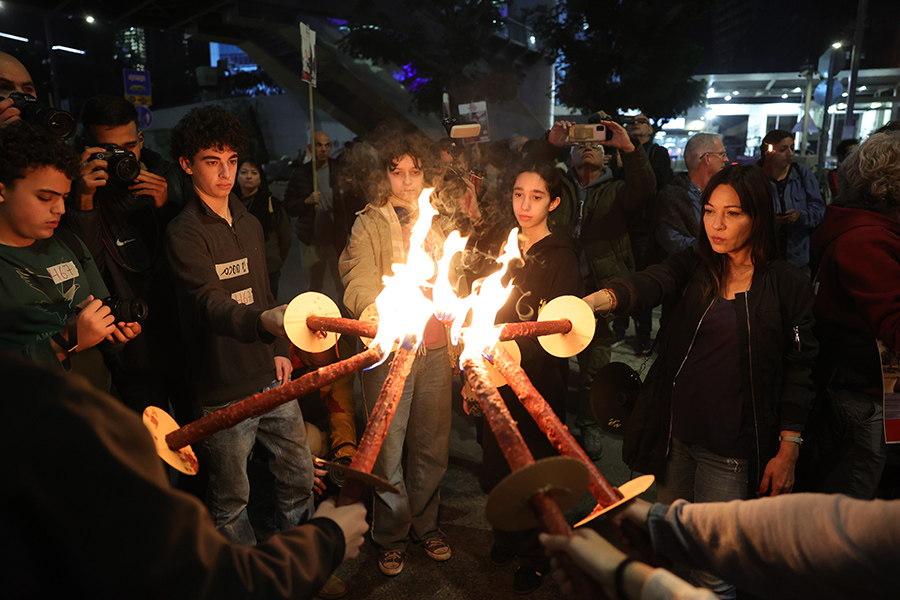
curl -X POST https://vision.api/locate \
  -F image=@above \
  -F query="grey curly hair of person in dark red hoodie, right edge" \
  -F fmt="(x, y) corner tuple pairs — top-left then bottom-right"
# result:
(844, 131), (900, 210)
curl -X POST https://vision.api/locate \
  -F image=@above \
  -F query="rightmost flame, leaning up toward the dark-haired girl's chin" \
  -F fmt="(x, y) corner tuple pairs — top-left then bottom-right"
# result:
(451, 229), (521, 361)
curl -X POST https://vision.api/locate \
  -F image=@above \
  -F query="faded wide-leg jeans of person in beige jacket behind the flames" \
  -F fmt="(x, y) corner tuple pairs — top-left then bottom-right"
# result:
(362, 347), (451, 550)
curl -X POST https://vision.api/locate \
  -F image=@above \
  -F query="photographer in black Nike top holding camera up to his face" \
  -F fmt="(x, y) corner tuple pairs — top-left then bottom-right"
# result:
(63, 96), (192, 419)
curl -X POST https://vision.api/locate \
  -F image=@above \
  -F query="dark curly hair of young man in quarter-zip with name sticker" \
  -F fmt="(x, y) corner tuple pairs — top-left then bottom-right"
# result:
(171, 104), (247, 161)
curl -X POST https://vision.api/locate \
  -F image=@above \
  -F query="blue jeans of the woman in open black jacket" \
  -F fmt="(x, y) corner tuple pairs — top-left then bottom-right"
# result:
(656, 439), (749, 599)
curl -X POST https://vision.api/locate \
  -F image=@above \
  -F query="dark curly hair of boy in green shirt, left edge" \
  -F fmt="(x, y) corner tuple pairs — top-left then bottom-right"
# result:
(0, 121), (80, 186)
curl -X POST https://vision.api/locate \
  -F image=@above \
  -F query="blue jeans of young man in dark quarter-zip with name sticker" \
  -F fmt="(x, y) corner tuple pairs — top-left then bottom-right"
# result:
(202, 384), (315, 546)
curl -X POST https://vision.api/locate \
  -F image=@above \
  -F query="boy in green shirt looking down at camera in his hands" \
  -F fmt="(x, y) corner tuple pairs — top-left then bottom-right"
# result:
(0, 122), (141, 391)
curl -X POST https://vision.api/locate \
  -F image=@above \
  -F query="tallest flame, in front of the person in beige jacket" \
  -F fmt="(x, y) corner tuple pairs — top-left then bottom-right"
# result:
(370, 188), (437, 368)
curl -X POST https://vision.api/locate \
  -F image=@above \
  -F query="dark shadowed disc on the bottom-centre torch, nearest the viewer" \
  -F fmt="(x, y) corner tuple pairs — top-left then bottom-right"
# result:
(484, 456), (589, 531)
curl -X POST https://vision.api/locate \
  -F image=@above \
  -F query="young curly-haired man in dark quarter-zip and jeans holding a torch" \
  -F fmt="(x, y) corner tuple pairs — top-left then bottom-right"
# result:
(166, 105), (345, 597)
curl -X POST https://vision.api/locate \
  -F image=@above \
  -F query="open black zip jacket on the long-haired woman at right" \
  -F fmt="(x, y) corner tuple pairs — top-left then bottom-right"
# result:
(609, 249), (818, 497)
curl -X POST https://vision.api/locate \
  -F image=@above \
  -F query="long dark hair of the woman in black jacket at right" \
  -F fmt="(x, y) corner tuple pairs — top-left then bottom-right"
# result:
(697, 165), (778, 293)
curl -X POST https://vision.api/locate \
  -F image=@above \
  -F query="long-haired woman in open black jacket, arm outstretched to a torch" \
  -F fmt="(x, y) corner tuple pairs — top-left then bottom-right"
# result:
(585, 166), (818, 597)
